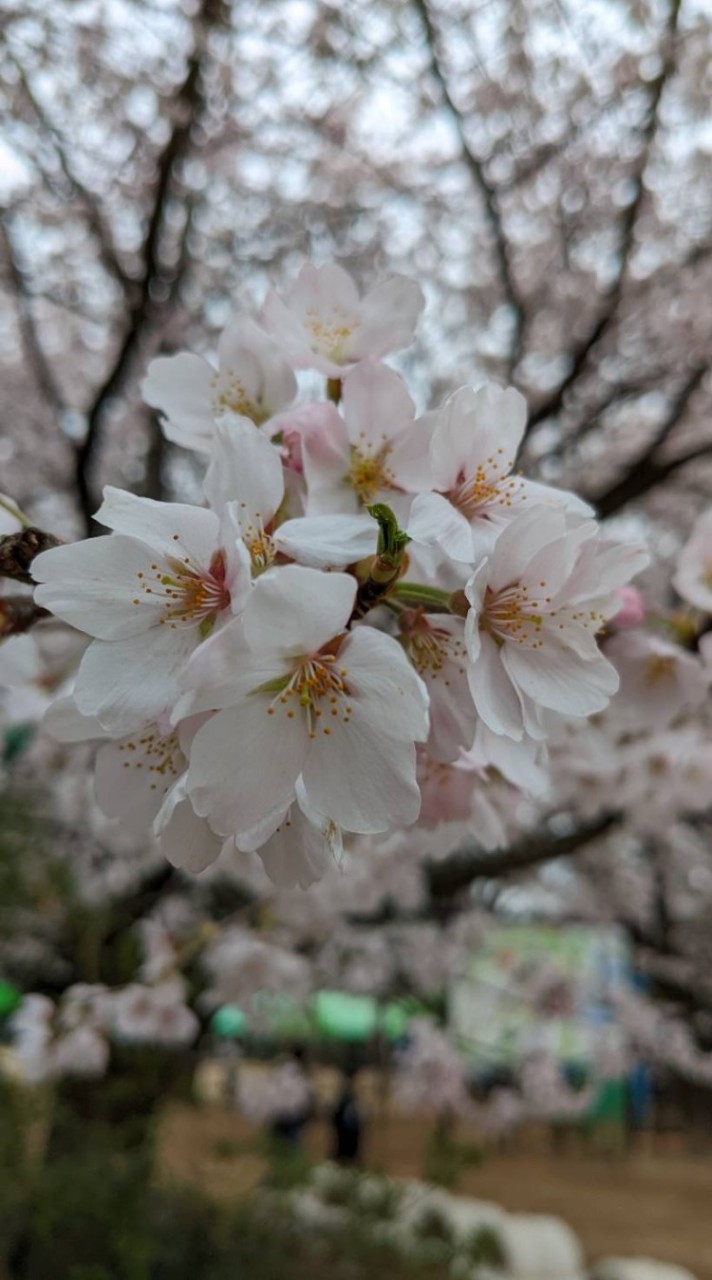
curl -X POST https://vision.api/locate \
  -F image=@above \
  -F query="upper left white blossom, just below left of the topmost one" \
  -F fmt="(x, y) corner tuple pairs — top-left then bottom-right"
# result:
(141, 316), (297, 454)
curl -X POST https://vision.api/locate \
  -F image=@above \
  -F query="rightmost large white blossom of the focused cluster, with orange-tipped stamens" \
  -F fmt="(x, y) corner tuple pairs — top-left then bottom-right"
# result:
(466, 507), (647, 740)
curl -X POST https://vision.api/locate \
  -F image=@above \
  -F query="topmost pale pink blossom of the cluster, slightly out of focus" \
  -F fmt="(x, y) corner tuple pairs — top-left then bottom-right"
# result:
(260, 262), (424, 378)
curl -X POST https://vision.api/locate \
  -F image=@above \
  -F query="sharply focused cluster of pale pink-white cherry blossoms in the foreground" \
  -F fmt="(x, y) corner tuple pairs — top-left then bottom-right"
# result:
(32, 265), (647, 886)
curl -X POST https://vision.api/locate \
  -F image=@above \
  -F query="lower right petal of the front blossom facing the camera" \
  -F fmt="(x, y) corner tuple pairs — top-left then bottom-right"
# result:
(302, 705), (420, 835)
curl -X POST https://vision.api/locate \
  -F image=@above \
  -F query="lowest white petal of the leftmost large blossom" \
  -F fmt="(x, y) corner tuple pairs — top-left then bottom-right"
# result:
(74, 627), (196, 737)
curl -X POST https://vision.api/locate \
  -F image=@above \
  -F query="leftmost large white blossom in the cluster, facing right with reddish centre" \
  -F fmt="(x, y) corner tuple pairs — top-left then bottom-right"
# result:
(32, 488), (250, 736)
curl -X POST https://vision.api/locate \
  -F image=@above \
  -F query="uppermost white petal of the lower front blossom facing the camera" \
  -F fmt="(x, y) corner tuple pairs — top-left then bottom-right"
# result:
(242, 564), (356, 657)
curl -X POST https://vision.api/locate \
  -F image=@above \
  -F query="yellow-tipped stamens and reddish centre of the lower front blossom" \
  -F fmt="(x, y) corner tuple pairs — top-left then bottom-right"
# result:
(262, 653), (353, 737)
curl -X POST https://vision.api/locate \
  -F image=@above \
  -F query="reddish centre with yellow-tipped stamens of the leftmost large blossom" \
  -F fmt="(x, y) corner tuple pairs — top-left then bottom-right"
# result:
(133, 547), (231, 628)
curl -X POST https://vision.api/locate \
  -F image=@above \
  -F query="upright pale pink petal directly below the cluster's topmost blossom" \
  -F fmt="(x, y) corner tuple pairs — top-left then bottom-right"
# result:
(342, 360), (415, 449)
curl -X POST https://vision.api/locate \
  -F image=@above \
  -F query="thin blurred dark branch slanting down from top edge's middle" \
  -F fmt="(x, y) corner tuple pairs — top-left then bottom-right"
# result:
(412, 0), (526, 376)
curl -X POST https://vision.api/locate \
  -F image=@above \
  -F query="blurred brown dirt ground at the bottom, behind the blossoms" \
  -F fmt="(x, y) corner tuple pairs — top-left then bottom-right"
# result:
(160, 1106), (712, 1280)
